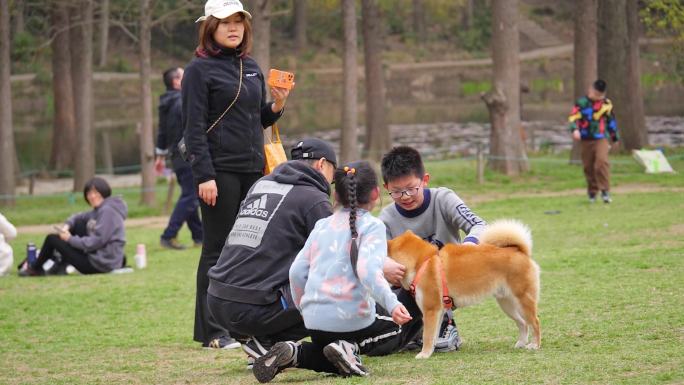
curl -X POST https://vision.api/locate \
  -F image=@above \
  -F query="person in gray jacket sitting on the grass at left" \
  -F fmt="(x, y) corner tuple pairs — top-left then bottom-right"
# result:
(19, 177), (128, 276)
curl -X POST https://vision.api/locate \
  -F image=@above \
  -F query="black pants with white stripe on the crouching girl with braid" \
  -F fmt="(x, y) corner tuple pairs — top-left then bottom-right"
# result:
(298, 289), (423, 373)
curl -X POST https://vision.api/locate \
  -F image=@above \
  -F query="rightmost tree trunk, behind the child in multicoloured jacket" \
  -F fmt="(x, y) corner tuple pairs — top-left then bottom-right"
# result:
(618, 1), (648, 150)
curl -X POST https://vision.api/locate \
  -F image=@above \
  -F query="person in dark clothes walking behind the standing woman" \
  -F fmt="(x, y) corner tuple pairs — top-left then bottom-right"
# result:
(154, 67), (202, 250)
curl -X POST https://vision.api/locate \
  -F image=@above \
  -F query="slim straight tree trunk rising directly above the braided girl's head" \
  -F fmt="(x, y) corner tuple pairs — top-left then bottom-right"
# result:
(340, 0), (359, 163)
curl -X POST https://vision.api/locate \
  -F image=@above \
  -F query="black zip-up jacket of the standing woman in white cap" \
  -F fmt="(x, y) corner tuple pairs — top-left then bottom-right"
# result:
(181, 49), (282, 184)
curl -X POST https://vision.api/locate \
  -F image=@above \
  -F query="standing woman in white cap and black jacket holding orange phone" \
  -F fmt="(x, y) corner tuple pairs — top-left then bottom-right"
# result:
(182, 0), (289, 349)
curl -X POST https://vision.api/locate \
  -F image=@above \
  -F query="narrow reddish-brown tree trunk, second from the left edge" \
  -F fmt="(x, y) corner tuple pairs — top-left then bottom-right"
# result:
(50, 2), (76, 170)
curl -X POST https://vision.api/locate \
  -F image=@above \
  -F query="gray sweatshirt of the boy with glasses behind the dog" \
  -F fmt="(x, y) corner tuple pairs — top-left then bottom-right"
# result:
(380, 187), (487, 245)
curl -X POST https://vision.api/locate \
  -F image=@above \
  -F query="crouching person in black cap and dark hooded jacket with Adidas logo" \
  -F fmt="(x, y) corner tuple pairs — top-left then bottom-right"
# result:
(207, 139), (337, 359)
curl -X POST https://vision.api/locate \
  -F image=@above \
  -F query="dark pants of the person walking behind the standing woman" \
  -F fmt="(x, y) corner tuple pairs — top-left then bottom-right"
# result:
(161, 156), (202, 243)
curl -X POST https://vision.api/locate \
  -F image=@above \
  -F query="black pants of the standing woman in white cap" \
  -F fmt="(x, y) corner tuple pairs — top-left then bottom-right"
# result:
(194, 172), (262, 345)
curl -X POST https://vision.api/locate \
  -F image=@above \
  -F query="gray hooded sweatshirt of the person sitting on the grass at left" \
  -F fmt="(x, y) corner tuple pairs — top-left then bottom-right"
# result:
(66, 197), (128, 273)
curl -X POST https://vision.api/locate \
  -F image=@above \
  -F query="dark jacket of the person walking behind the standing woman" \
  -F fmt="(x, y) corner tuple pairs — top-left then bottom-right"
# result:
(157, 90), (183, 156)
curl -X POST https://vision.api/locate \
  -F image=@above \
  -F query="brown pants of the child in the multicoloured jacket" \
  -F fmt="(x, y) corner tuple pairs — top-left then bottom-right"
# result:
(582, 139), (610, 196)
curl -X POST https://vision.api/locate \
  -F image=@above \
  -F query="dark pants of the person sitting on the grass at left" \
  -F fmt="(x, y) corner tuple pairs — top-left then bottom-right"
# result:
(31, 222), (103, 274)
